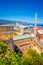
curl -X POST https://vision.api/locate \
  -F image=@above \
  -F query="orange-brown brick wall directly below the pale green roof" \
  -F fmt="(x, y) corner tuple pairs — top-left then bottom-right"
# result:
(14, 38), (33, 54)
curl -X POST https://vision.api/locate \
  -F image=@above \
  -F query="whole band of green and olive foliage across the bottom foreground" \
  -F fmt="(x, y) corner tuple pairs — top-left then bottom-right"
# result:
(0, 42), (43, 65)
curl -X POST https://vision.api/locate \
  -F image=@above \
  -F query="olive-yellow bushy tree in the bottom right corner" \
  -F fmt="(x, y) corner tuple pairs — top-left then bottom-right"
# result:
(28, 49), (43, 65)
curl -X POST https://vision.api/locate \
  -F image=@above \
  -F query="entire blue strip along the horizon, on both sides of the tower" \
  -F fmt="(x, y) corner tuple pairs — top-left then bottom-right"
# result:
(0, 19), (43, 27)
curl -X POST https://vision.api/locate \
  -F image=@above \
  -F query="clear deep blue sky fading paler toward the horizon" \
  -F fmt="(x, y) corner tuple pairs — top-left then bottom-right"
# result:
(0, 0), (43, 24)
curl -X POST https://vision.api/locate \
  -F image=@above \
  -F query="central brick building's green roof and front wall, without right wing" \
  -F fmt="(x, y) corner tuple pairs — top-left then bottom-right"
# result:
(13, 34), (34, 54)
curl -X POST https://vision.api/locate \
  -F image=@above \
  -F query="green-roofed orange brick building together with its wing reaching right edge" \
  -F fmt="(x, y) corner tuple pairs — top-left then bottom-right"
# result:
(13, 34), (43, 55)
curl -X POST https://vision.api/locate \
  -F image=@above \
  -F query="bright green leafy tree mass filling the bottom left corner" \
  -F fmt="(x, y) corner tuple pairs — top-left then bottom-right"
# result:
(0, 42), (21, 65)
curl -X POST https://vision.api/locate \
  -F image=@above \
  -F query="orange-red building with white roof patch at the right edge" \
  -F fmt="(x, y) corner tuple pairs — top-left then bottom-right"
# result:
(35, 28), (43, 52)
